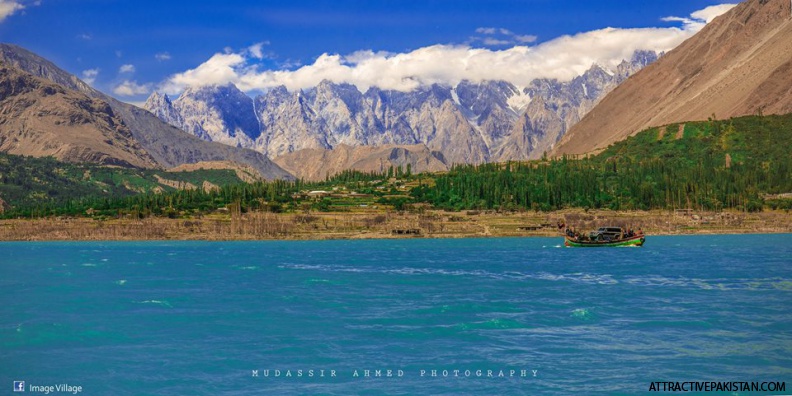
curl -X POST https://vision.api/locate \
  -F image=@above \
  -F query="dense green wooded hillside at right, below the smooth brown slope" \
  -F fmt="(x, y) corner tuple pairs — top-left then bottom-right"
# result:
(413, 115), (792, 211)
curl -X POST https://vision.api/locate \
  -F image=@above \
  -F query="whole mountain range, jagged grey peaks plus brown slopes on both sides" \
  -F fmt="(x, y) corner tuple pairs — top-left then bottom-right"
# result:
(0, 0), (792, 186)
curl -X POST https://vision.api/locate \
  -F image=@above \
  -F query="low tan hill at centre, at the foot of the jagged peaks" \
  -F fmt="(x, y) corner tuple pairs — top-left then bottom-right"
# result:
(274, 144), (448, 180)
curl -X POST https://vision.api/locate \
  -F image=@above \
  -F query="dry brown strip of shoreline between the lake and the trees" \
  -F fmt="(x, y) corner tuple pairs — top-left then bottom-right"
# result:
(0, 209), (792, 242)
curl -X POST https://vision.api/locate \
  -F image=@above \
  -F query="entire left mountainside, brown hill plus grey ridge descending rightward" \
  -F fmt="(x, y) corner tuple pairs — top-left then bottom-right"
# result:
(0, 44), (292, 179)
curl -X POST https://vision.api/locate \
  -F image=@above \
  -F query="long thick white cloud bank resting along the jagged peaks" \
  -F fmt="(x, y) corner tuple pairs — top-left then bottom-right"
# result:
(160, 5), (731, 93)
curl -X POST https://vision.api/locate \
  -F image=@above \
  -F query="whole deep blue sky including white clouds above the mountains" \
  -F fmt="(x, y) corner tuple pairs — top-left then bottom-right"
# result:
(0, 0), (728, 102)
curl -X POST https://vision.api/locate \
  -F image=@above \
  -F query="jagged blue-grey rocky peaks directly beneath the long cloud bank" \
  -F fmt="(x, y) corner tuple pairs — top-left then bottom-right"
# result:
(144, 51), (657, 177)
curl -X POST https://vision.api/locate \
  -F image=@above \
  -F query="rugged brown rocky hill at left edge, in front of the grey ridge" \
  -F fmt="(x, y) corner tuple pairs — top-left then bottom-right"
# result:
(0, 62), (157, 168)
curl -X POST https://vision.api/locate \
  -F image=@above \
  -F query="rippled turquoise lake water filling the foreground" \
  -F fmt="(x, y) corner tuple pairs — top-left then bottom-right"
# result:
(0, 234), (792, 395)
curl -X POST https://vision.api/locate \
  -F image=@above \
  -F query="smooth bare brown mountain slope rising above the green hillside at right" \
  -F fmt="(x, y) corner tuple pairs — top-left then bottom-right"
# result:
(553, 0), (792, 155)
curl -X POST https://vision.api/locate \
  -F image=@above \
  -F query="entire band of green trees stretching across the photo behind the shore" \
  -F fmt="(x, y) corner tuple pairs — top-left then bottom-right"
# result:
(0, 115), (792, 218)
